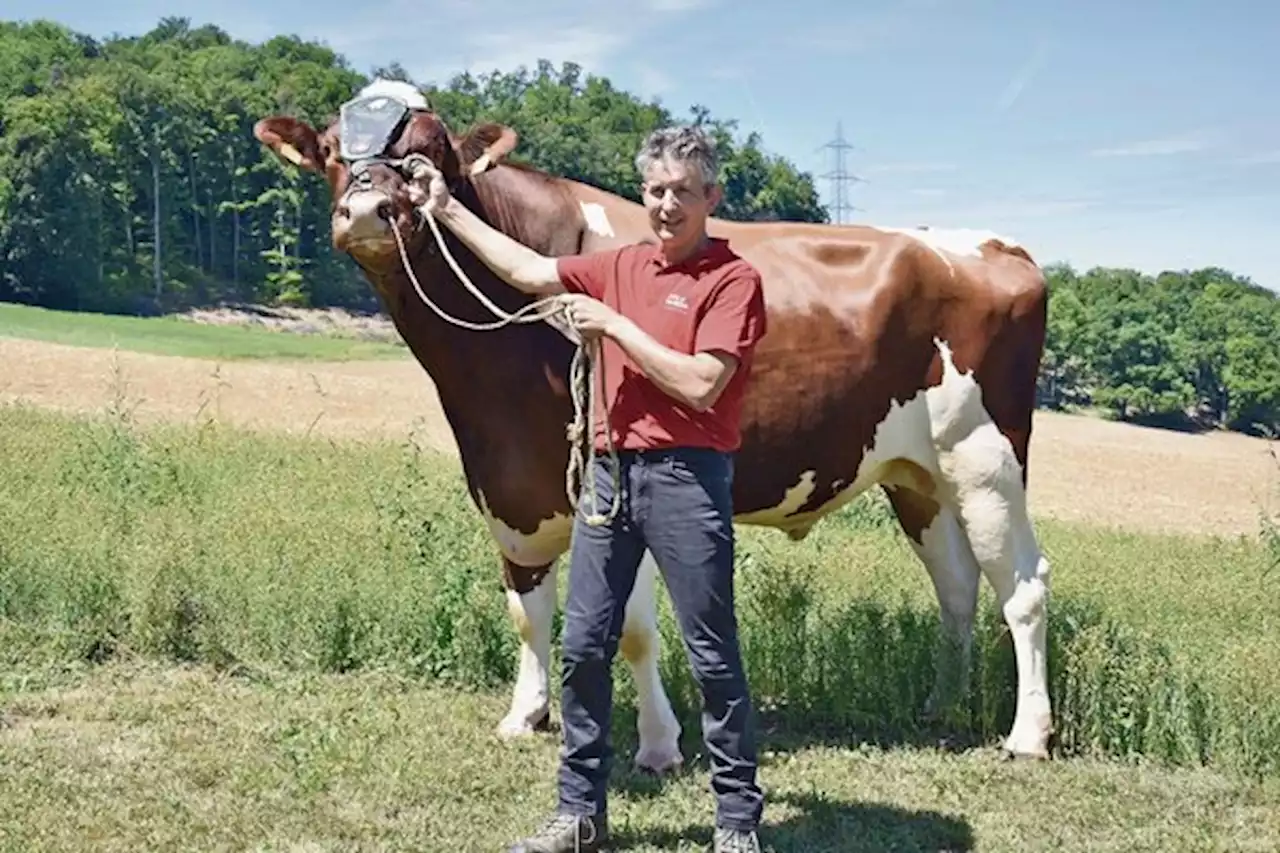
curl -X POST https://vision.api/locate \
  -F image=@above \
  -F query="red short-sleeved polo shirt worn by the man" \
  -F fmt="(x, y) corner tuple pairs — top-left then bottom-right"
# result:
(558, 240), (765, 451)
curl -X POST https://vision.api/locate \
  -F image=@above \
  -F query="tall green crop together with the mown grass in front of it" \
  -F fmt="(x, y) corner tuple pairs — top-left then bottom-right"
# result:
(0, 406), (1280, 850)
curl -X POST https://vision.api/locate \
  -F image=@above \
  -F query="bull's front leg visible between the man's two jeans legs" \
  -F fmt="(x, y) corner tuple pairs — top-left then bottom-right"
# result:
(618, 551), (684, 774)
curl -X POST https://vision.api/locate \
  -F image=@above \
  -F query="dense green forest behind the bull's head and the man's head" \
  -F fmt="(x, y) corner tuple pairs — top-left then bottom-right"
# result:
(0, 24), (824, 313)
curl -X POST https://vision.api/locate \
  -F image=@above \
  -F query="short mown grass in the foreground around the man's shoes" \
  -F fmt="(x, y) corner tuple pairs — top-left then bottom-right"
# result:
(0, 663), (1280, 853)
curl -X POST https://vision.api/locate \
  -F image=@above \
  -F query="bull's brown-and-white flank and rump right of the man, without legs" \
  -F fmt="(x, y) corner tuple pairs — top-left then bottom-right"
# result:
(735, 227), (1042, 526)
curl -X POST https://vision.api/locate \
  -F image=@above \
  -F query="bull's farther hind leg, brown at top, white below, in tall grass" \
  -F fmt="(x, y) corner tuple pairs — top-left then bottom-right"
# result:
(886, 488), (982, 719)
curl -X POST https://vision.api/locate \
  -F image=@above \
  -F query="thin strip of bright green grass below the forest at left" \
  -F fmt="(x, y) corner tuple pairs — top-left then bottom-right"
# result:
(0, 304), (407, 361)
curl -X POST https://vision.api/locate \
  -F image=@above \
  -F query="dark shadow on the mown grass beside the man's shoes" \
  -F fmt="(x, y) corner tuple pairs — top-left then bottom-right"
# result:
(613, 794), (974, 853)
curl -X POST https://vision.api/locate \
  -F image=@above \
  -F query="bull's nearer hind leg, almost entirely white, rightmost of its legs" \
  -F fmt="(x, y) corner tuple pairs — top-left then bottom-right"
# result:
(941, 420), (1053, 758)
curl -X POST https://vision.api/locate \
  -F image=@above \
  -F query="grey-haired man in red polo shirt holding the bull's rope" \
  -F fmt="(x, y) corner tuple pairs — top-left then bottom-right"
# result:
(415, 127), (765, 853)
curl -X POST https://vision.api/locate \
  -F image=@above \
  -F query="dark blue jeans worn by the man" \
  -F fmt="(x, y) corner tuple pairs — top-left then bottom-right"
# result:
(559, 448), (764, 830)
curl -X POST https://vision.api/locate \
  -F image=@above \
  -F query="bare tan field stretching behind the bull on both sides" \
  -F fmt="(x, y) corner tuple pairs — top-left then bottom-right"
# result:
(0, 338), (1280, 535)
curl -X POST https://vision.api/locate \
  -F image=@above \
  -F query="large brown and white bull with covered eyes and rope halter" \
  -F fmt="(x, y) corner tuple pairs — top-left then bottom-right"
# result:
(255, 81), (1052, 771)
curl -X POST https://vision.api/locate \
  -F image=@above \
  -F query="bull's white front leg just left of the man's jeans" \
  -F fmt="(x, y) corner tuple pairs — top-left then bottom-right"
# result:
(498, 562), (557, 738)
